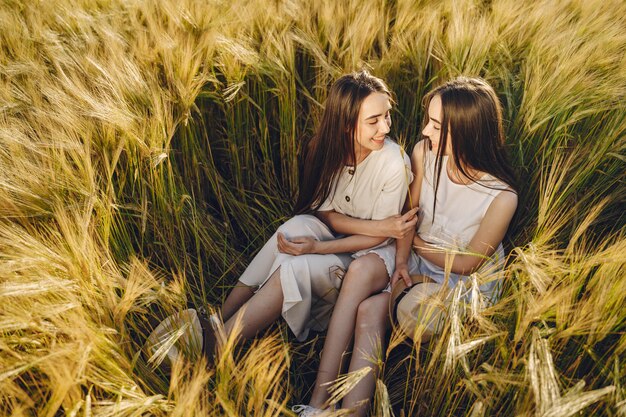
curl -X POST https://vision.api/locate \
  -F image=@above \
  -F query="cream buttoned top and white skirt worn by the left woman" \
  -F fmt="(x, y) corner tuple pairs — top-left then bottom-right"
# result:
(239, 139), (412, 340)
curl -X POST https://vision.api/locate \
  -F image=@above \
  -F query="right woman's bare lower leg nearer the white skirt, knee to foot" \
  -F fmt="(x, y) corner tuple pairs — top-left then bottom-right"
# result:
(311, 254), (389, 408)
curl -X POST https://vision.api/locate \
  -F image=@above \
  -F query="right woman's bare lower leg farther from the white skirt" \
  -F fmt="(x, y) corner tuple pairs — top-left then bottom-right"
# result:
(341, 292), (390, 416)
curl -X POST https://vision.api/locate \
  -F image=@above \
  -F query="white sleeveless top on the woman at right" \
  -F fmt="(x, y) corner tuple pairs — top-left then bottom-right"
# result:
(418, 151), (509, 292)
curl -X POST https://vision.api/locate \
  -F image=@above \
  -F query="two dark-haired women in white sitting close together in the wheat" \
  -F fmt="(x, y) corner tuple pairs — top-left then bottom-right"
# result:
(147, 71), (517, 416)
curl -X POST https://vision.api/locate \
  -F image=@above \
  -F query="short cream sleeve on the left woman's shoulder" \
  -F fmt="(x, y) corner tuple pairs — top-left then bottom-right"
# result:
(372, 151), (413, 220)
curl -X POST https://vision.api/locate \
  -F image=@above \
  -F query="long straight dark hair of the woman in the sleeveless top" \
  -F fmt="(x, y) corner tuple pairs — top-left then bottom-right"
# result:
(424, 77), (517, 211)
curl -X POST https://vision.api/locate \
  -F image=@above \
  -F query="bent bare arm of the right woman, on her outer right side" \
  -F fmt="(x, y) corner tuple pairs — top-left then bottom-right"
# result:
(413, 191), (517, 275)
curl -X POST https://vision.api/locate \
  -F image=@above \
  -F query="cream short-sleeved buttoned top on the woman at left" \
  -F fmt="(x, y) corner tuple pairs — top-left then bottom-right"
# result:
(318, 138), (413, 220)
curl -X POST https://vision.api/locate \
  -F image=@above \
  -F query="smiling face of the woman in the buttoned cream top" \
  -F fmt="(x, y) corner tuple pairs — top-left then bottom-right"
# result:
(354, 93), (391, 163)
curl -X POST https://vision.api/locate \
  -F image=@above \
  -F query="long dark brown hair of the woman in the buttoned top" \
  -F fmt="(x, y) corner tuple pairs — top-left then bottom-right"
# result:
(294, 71), (391, 214)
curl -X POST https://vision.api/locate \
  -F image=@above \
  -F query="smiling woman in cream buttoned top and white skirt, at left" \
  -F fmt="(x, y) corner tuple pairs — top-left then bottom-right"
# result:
(149, 71), (417, 366)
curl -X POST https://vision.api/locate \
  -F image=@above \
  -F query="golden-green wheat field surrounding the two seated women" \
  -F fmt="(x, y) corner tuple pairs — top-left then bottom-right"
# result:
(0, 0), (626, 417)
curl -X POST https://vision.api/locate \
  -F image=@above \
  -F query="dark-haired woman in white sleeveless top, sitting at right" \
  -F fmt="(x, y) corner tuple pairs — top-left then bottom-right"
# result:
(294, 77), (517, 416)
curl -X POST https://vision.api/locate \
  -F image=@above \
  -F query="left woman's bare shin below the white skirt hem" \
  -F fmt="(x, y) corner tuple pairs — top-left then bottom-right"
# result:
(224, 268), (283, 339)
